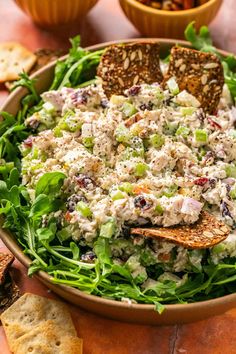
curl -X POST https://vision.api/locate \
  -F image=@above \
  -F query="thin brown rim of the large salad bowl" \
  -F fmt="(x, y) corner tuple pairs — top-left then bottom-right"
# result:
(0, 38), (236, 313)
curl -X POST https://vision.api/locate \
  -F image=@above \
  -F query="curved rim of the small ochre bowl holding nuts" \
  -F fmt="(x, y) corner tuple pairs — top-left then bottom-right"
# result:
(119, 0), (222, 17)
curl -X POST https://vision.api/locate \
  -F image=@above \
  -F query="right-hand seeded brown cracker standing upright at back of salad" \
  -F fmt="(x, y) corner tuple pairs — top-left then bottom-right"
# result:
(164, 47), (224, 114)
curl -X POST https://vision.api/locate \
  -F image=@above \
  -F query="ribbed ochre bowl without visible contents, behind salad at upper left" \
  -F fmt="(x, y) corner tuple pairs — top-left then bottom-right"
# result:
(15, 0), (98, 27)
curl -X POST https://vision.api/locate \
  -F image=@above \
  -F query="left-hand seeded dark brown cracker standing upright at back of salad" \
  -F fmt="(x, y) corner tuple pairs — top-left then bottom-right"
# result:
(97, 42), (163, 97)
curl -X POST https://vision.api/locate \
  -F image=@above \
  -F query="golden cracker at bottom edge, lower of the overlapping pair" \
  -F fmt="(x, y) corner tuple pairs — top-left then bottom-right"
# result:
(14, 320), (83, 354)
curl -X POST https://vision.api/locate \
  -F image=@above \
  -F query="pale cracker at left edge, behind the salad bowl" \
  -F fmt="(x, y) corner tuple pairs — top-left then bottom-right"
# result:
(0, 42), (36, 82)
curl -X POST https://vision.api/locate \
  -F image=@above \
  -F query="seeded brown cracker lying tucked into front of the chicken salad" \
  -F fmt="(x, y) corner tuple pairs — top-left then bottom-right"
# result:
(131, 211), (230, 249)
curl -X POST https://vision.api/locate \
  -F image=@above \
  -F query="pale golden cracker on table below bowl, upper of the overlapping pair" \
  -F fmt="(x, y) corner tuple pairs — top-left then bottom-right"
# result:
(1, 293), (76, 351)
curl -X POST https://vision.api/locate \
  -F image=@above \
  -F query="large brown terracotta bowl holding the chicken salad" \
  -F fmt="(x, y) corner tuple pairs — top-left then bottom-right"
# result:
(0, 39), (236, 325)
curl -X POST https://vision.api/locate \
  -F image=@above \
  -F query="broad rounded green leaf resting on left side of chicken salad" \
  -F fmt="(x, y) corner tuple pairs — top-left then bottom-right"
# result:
(35, 172), (66, 198)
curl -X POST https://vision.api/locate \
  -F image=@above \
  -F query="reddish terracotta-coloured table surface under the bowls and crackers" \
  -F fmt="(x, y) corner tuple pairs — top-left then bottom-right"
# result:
(0, 0), (236, 354)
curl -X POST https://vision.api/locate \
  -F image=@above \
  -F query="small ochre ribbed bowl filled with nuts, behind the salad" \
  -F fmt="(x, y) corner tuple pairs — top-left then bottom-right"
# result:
(120, 0), (223, 39)
